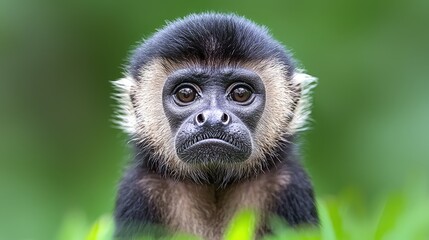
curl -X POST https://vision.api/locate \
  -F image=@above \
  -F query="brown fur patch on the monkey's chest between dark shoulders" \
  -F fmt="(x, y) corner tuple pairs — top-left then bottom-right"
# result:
(162, 183), (270, 239)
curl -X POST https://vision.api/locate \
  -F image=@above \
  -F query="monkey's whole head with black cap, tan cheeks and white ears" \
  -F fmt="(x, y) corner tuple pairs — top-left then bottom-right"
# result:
(115, 14), (315, 183)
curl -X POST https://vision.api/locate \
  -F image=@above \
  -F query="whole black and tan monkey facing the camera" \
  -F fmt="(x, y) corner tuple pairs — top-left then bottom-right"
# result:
(114, 13), (319, 239)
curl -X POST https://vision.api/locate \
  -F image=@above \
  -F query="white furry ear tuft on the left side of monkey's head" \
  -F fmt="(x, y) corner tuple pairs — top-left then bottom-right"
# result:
(112, 75), (137, 136)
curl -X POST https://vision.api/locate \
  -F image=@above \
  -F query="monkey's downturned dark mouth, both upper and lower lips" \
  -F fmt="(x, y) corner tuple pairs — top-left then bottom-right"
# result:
(176, 131), (251, 163)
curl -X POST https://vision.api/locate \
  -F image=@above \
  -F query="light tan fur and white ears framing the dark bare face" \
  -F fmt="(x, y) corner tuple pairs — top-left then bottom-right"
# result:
(114, 59), (316, 177)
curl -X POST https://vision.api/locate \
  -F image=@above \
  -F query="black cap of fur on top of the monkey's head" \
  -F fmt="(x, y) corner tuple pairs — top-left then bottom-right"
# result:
(127, 13), (295, 79)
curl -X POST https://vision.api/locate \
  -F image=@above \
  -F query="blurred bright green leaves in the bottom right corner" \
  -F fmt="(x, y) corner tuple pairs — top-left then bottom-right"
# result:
(266, 188), (429, 240)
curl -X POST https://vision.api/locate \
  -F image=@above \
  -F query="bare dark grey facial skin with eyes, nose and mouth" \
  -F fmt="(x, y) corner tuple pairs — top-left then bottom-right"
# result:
(162, 68), (265, 165)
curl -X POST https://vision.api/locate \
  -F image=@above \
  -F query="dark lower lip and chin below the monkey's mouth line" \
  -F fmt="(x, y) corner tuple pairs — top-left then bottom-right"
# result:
(177, 139), (251, 165)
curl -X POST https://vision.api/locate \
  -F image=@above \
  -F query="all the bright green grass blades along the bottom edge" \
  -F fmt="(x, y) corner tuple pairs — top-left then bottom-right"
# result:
(58, 187), (429, 240)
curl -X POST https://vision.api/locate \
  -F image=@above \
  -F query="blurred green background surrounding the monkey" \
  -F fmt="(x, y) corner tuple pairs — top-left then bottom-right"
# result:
(0, 0), (429, 240)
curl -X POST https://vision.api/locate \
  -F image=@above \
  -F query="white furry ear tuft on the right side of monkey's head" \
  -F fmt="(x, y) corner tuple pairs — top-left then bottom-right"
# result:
(289, 69), (317, 133)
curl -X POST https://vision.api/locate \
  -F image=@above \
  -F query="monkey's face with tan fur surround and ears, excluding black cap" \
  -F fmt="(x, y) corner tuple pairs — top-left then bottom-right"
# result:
(115, 59), (314, 183)
